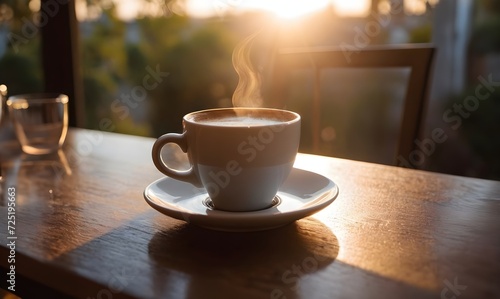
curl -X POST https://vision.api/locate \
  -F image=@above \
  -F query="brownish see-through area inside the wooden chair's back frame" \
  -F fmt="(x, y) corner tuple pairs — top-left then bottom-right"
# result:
(287, 68), (410, 164)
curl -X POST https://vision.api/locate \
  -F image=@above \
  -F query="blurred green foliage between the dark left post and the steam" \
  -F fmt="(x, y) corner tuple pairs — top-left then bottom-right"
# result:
(82, 5), (237, 136)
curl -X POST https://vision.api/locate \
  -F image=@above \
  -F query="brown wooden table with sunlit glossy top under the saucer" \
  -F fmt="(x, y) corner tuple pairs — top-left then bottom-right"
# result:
(0, 129), (500, 299)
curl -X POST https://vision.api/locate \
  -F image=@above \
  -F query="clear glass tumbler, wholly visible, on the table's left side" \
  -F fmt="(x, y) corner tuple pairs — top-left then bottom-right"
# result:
(7, 94), (68, 155)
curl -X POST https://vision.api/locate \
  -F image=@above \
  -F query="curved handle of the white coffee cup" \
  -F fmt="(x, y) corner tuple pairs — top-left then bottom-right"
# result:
(152, 133), (202, 187)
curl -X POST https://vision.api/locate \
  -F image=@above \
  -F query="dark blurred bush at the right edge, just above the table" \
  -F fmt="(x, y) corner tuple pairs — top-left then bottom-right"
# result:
(428, 86), (500, 180)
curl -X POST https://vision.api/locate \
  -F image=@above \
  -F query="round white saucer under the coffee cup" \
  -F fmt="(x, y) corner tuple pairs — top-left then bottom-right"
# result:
(144, 168), (339, 231)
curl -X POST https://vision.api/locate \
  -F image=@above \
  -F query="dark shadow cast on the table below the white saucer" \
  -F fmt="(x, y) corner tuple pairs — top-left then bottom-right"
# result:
(148, 217), (339, 298)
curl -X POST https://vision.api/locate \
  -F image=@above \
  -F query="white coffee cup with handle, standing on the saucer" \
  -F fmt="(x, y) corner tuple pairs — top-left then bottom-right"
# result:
(152, 108), (300, 212)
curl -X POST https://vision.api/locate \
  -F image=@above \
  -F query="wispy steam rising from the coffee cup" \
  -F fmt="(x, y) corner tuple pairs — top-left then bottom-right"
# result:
(232, 31), (263, 107)
